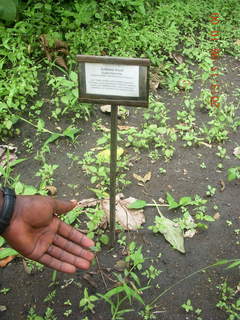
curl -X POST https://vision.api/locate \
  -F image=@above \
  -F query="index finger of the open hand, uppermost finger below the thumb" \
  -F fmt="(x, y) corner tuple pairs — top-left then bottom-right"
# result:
(58, 221), (94, 248)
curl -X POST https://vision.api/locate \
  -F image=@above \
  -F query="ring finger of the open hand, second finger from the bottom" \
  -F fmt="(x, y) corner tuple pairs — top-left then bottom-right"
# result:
(47, 245), (90, 270)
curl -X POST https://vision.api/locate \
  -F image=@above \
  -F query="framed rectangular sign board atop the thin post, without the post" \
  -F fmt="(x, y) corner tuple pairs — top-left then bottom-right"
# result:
(77, 55), (150, 107)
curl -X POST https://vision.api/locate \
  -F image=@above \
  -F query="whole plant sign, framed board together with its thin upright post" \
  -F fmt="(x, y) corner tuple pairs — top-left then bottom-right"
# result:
(77, 55), (150, 246)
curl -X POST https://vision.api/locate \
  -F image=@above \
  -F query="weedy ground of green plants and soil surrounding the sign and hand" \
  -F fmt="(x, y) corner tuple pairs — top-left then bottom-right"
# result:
(0, 0), (240, 320)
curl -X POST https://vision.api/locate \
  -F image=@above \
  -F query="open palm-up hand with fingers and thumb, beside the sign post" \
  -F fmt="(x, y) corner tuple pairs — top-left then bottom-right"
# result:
(2, 196), (94, 273)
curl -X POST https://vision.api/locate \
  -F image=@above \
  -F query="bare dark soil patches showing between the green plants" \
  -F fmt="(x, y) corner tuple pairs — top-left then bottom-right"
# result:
(0, 57), (240, 320)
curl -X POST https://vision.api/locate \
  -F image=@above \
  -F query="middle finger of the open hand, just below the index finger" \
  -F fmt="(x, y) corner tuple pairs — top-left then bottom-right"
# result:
(53, 234), (94, 261)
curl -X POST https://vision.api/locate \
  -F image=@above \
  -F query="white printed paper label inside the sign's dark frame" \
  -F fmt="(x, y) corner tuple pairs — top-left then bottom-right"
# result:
(85, 63), (139, 97)
